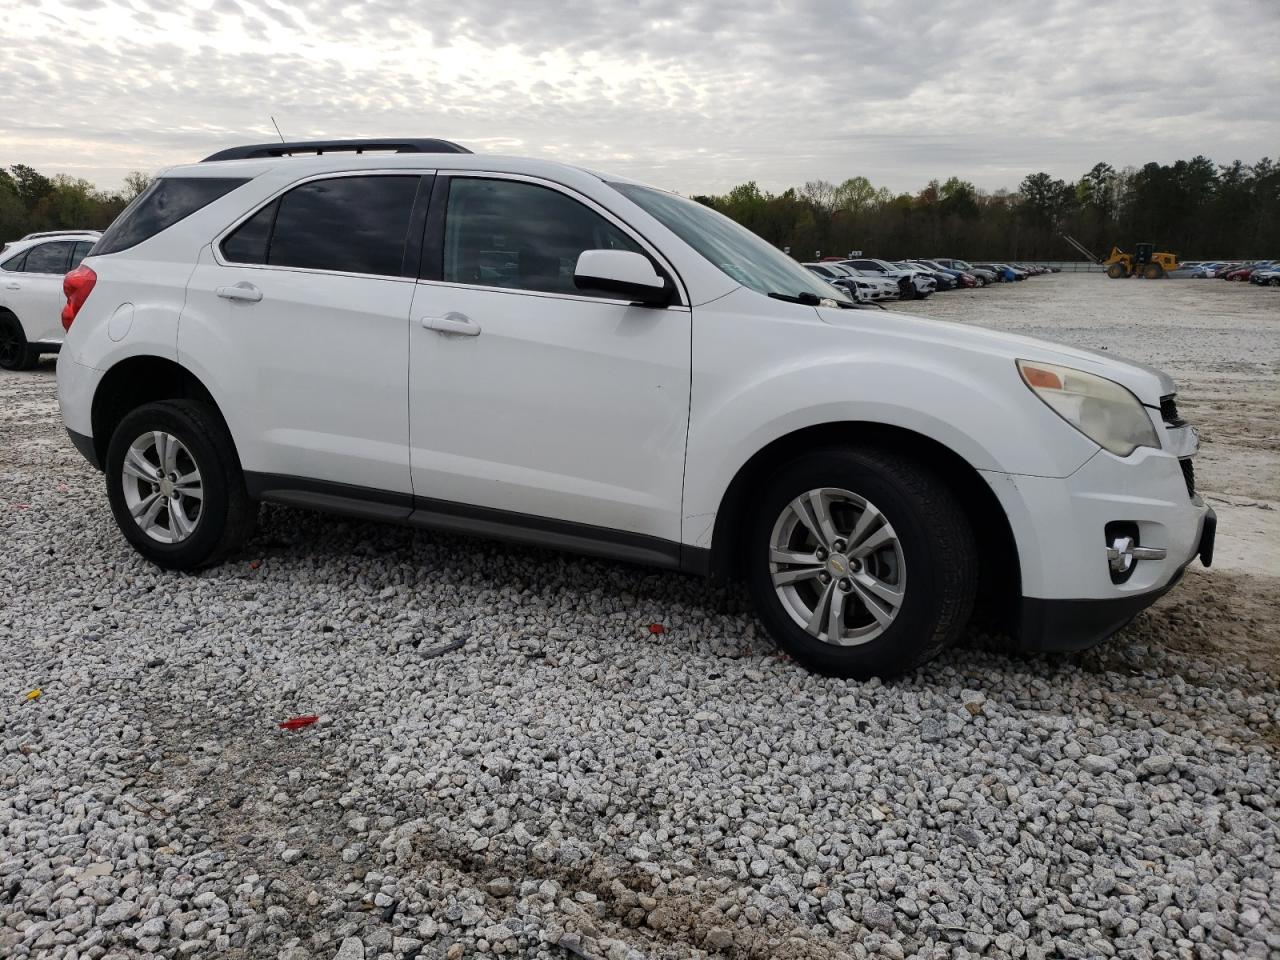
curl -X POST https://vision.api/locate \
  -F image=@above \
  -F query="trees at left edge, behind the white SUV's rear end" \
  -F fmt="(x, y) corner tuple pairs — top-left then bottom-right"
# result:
(0, 164), (151, 246)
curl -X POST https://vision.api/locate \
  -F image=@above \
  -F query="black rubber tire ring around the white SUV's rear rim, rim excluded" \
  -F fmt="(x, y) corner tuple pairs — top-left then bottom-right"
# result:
(105, 403), (229, 570)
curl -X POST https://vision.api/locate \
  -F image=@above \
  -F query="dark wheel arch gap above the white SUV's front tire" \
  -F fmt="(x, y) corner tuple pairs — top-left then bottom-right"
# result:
(708, 421), (1021, 624)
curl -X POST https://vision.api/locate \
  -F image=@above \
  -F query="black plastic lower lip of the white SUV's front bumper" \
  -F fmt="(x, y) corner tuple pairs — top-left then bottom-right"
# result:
(1016, 508), (1217, 650)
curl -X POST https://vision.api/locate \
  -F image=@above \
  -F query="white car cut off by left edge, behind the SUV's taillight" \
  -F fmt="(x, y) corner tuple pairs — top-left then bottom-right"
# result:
(0, 230), (101, 370)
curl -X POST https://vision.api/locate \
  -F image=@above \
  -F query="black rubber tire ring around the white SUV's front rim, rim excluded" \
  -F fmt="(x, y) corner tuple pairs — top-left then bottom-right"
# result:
(745, 451), (962, 677)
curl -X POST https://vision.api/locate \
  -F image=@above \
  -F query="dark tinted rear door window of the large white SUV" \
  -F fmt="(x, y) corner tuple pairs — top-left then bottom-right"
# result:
(266, 177), (419, 276)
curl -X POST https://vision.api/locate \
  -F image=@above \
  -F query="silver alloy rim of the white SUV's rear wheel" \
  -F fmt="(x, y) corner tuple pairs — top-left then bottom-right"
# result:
(120, 430), (205, 544)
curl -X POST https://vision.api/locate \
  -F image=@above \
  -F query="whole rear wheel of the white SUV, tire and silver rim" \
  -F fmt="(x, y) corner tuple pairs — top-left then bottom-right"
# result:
(105, 399), (257, 571)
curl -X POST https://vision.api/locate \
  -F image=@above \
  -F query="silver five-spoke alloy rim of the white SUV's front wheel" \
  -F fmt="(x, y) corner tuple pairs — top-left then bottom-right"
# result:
(769, 486), (906, 646)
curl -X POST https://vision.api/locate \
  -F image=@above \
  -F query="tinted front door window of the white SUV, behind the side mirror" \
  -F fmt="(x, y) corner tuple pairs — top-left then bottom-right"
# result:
(442, 178), (644, 297)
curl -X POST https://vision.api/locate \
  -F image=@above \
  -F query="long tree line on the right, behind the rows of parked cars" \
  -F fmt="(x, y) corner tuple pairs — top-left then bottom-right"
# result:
(694, 156), (1280, 260)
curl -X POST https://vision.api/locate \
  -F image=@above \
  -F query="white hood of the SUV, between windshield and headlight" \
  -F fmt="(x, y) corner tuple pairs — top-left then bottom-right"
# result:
(815, 307), (1178, 407)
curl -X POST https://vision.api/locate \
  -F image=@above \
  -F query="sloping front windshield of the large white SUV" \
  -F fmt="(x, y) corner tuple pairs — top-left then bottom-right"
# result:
(609, 183), (851, 302)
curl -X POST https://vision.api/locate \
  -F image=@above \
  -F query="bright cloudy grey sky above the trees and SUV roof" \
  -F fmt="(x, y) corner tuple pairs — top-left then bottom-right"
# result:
(0, 0), (1280, 193)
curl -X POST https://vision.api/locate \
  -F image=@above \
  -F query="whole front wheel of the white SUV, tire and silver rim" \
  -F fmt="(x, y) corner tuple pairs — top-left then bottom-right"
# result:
(745, 447), (979, 680)
